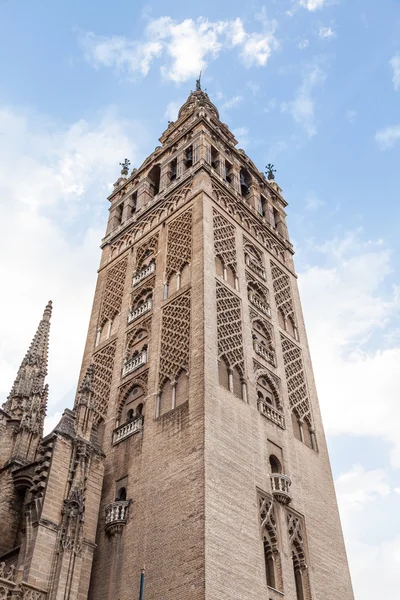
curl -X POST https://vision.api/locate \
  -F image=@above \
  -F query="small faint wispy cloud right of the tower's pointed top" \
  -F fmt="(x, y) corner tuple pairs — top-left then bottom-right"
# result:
(281, 65), (325, 137)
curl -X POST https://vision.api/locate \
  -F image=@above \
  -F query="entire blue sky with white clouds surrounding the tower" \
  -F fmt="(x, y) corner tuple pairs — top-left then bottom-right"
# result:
(0, 0), (400, 600)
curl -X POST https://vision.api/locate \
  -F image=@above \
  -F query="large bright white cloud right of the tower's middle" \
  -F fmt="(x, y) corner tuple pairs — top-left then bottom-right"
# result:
(299, 232), (400, 467)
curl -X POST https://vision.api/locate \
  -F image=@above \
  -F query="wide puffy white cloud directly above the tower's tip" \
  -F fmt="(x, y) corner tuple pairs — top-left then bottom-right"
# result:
(81, 13), (278, 83)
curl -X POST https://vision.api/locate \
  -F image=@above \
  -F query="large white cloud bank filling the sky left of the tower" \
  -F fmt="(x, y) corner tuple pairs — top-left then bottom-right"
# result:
(0, 107), (142, 414)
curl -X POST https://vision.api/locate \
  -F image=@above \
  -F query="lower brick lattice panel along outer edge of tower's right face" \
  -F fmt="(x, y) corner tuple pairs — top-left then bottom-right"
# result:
(281, 333), (312, 425)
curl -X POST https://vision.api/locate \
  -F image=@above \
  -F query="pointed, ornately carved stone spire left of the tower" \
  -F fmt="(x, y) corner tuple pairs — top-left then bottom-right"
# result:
(3, 300), (52, 428)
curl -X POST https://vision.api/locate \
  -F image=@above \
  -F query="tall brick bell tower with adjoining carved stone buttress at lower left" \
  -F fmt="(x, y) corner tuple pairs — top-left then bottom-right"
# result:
(0, 82), (353, 600)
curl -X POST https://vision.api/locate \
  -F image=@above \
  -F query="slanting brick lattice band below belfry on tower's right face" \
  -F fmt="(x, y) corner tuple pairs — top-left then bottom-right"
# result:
(212, 181), (286, 262)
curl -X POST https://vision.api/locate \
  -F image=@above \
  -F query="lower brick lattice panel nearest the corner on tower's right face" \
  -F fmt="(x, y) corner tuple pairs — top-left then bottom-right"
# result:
(216, 281), (244, 375)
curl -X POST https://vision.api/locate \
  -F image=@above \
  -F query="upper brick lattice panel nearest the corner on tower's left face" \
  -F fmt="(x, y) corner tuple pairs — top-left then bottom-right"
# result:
(165, 208), (192, 281)
